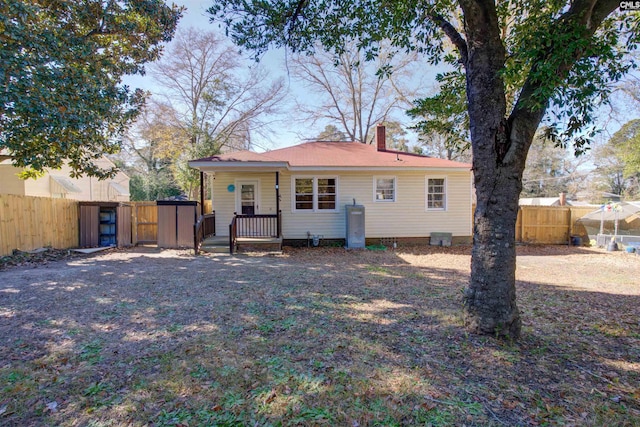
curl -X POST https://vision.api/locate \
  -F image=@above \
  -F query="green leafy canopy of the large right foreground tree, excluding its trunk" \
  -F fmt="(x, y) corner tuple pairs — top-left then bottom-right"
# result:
(209, 0), (638, 148)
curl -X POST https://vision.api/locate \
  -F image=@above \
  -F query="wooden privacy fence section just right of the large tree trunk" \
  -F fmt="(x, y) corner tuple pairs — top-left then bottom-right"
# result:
(516, 206), (596, 245)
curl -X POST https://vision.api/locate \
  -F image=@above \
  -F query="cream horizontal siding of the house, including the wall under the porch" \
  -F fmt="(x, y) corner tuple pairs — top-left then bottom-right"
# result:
(212, 170), (472, 239)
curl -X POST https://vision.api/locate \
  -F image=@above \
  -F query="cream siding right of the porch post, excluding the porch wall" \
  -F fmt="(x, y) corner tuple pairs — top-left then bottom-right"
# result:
(278, 170), (472, 239)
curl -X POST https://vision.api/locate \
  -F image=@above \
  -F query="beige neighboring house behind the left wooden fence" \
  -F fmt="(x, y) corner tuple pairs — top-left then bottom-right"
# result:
(0, 153), (130, 202)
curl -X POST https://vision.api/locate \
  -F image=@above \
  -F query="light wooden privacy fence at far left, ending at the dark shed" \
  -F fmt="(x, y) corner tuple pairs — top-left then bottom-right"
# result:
(0, 194), (79, 256)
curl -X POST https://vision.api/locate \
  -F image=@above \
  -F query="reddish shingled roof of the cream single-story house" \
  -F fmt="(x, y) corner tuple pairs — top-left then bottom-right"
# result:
(189, 142), (471, 170)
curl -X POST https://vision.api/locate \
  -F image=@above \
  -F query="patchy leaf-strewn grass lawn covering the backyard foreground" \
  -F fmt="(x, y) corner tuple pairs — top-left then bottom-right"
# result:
(0, 247), (640, 426)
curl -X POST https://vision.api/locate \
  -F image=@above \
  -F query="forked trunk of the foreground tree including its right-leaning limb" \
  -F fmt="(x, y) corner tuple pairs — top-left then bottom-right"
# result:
(456, 0), (619, 338)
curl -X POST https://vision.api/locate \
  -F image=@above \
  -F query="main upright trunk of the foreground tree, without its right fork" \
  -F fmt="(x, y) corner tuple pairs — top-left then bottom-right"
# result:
(461, 0), (524, 338)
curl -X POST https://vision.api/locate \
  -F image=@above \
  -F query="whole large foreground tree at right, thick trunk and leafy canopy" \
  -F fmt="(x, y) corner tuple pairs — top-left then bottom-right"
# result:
(209, 0), (638, 337)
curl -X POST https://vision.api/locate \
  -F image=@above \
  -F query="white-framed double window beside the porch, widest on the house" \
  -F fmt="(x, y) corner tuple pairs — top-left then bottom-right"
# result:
(292, 177), (338, 212)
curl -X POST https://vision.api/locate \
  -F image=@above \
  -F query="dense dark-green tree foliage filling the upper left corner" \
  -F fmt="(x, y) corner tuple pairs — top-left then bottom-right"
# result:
(0, 0), (182, 177)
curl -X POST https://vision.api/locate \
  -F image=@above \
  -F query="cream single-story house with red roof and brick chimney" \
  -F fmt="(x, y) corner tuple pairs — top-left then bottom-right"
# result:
(189, 125), (473, 247)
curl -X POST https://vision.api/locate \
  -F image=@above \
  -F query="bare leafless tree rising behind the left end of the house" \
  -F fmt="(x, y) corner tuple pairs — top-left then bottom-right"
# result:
(151, 28), (285, 197)
